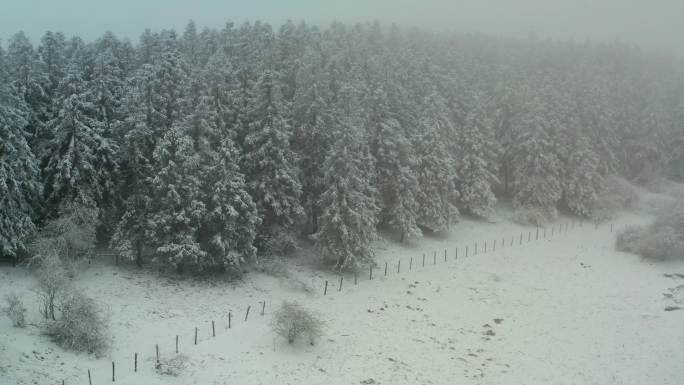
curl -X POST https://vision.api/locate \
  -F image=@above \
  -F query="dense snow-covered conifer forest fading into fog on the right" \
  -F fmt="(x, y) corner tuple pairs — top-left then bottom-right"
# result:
(0, 22), (684, 270)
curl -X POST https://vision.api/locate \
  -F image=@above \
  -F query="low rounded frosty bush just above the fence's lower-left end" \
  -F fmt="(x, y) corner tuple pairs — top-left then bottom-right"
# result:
(47, 292), (109, 355)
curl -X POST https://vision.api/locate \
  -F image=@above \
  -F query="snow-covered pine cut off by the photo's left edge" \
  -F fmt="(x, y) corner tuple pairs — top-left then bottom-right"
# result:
(0, 83), (42, 258)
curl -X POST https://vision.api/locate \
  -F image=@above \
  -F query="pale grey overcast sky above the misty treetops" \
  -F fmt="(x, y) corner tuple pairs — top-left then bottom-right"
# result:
(0, 0), (684, 54)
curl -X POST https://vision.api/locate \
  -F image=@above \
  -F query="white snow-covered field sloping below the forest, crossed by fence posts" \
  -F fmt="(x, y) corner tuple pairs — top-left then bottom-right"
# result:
(0, 210), (684, 385)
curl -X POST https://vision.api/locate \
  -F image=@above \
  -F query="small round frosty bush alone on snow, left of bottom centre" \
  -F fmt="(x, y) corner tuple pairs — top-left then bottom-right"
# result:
(271, 301), (324, 345)
